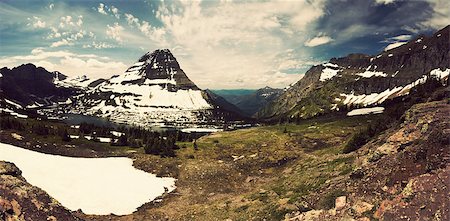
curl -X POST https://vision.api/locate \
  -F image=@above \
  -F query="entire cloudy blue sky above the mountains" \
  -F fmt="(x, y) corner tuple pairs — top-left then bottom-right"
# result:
(0, 0), (450, 89)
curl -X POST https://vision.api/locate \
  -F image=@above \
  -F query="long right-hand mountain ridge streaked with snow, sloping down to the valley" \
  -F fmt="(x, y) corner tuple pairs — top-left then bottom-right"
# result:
(256, 26), (450, 119)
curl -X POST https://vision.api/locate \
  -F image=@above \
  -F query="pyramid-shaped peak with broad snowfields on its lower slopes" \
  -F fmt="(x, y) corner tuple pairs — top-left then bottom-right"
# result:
(70, 49), (244, 126)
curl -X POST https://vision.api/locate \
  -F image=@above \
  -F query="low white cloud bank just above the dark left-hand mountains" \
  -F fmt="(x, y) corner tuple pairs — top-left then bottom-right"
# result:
(0, 48), (127, 78)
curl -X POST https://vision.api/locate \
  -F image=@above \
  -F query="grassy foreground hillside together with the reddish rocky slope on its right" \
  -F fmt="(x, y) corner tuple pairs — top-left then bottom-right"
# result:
(0, 93), (450, 220)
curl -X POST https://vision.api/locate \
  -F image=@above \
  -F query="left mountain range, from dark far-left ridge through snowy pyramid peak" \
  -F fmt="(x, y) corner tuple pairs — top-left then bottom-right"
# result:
(0, 49), (244, 126)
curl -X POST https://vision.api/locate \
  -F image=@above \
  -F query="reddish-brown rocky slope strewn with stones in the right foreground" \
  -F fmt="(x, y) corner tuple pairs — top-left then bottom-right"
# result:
(288, 100), (450, 221)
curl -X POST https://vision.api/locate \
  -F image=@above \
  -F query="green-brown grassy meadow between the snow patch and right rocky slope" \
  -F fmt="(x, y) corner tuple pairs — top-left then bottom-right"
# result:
(2, 113), (384, 220)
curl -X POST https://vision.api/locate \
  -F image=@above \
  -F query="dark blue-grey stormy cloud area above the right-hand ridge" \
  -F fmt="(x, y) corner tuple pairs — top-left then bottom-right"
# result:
(315, 0), (434, 58)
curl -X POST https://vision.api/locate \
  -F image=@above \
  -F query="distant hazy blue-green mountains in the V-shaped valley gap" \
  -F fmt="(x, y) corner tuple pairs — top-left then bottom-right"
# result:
(214, 87), (283, 116)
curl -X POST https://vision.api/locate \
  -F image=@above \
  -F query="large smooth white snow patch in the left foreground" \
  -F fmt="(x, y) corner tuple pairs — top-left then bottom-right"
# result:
(0, 143), (175, 215)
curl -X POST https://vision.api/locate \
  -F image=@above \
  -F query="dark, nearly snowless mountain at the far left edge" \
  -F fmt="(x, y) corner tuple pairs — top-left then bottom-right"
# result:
(0, 64), (77, 106)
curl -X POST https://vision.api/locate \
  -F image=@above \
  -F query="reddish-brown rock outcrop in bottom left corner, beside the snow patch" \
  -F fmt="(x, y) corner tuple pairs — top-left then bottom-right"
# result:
(0, 161), (80, 220)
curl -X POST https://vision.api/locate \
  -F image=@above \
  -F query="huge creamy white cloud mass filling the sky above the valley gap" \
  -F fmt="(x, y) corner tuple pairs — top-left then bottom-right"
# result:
(153, 1), (324, 88)
